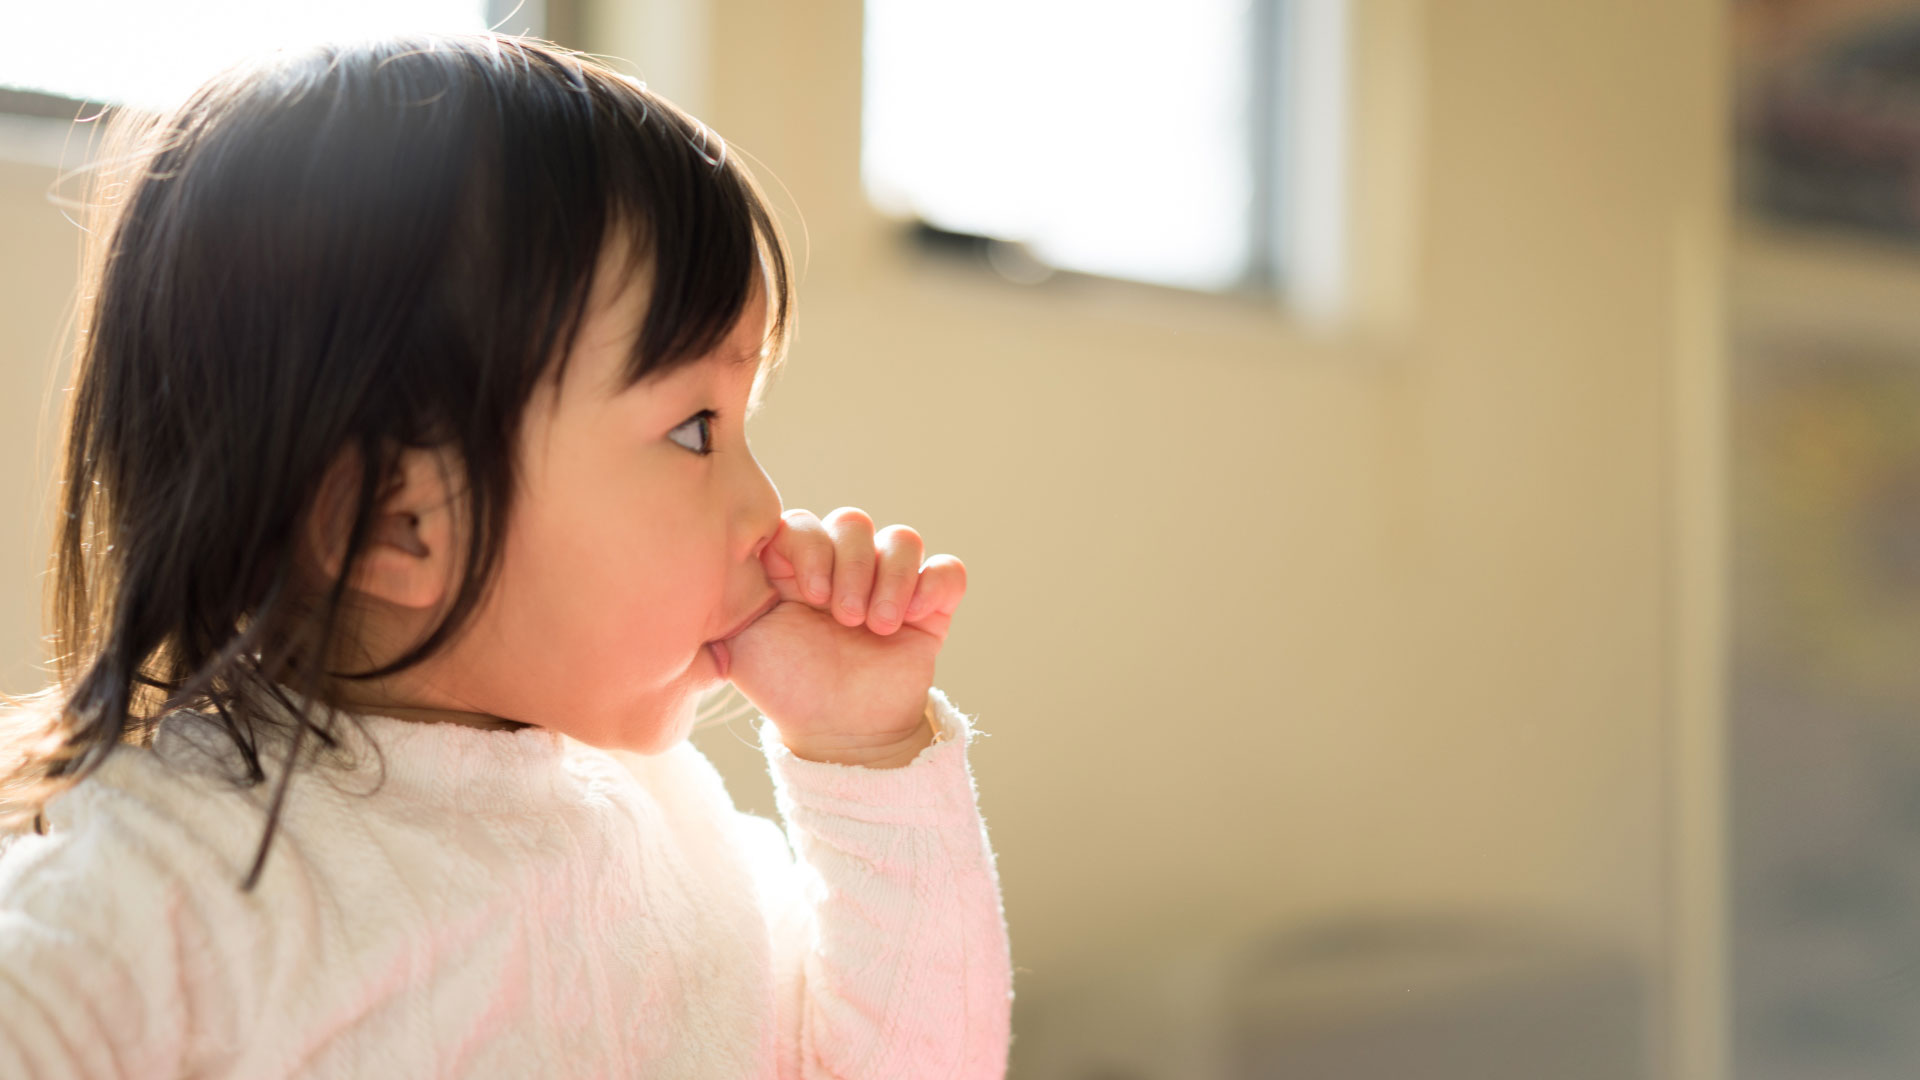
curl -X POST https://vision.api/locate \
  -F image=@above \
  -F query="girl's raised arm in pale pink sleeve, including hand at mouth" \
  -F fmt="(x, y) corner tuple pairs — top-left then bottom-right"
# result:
(728, 507), (1012, 1080)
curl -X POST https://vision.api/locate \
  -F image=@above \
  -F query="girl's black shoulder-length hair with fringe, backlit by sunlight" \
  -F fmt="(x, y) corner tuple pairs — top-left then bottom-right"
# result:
(4, 35), (791, 890)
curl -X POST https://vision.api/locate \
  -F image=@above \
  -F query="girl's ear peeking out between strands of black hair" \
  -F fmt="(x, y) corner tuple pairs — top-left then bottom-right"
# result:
(305, 448), (461, 607)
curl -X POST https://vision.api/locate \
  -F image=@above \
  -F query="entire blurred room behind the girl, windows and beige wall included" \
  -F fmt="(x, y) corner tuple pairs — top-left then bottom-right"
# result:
(0, 0), (1920, 1080)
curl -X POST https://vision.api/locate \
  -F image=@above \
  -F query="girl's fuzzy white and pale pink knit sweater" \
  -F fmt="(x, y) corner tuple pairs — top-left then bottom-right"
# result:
(0, 690), (1012, 1080)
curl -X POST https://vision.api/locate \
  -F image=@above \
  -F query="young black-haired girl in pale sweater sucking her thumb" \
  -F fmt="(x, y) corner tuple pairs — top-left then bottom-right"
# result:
(0, 35), (1010, 1078)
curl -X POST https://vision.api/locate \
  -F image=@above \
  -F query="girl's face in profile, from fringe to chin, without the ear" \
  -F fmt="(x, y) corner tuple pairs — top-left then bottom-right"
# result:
(357, 240), (781, 753)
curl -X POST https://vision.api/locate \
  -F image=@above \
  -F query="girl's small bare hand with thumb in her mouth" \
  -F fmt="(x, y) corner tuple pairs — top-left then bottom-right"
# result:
(728, 505), (966, 767)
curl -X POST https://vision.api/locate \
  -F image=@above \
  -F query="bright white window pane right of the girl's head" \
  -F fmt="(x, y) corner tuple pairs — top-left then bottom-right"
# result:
(862, 0), (1254, 288)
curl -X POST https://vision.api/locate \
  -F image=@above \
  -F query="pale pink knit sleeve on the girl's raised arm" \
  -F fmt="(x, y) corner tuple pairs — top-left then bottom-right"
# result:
(760, 688), (1012, 1080)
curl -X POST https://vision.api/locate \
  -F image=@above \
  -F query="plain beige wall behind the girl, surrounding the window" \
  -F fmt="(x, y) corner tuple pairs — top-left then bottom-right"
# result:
(0, 0), (1722, 1078)
